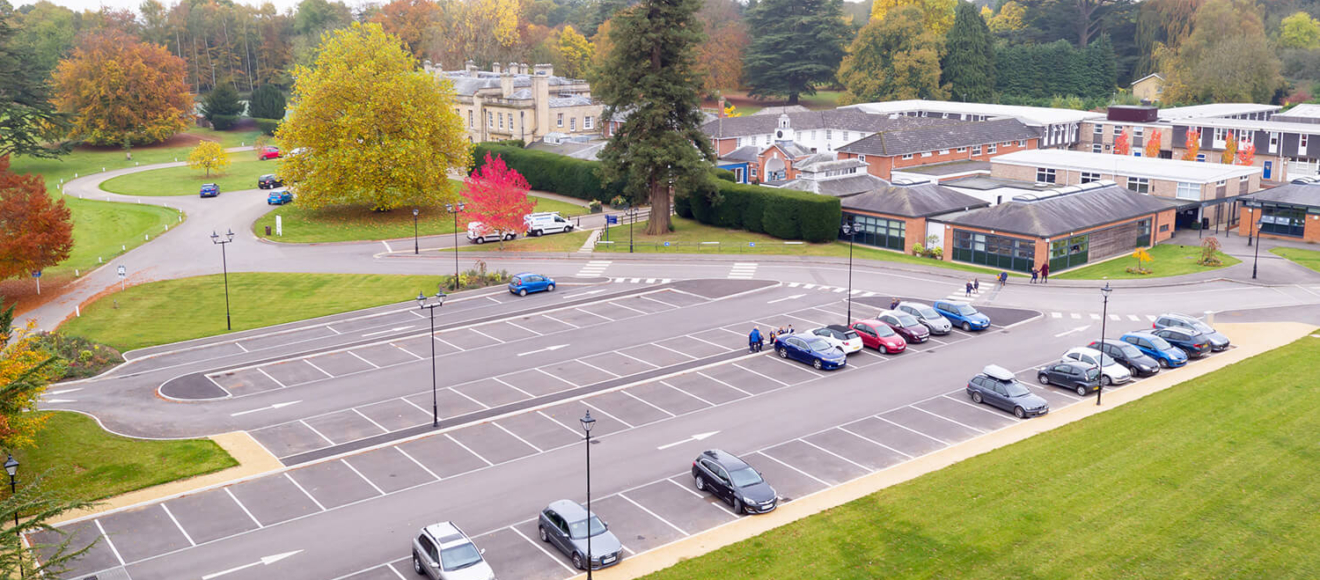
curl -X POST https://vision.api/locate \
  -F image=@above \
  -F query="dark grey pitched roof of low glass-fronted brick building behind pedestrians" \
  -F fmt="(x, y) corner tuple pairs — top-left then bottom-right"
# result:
(939, 181), (1176, 238)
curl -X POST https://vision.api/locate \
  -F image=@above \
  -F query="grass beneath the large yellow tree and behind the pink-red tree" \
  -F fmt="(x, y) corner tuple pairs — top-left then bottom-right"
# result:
(252, 192), (586, 243)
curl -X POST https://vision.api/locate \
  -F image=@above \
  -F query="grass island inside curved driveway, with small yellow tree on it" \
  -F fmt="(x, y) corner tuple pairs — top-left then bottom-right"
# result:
(100, 153), (280, 196)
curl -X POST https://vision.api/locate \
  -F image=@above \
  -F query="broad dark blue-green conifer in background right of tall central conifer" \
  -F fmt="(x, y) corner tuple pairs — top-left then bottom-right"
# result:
(743, 0), (850, 104)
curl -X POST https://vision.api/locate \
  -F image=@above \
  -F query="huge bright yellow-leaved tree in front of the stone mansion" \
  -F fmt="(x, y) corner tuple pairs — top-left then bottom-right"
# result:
(276, 22), (471, 211)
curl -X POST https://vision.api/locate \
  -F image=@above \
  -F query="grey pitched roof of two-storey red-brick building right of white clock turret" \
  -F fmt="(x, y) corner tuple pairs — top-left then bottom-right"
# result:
(838, 119), (1040, 156)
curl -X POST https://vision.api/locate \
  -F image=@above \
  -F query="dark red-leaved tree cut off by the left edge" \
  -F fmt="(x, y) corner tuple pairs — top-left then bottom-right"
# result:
(0, 156), (74, 284)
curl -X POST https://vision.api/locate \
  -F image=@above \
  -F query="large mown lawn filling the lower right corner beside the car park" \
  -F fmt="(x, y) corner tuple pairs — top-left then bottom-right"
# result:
(645, 337), (1320, 580)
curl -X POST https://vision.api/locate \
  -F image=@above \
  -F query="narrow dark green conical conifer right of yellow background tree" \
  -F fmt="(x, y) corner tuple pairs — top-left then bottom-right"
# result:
(940, 3), (994, 103)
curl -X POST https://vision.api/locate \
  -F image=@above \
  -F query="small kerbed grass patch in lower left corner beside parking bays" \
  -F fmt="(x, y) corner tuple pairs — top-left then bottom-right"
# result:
(15, 412), (238, 501)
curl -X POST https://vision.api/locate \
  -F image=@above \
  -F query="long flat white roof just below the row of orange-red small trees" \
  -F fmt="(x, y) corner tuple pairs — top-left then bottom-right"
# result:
(990, 149), (1261, 184)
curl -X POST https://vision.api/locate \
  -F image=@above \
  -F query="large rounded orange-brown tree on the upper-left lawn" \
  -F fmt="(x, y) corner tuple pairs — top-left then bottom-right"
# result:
(54, 30), (193, 145)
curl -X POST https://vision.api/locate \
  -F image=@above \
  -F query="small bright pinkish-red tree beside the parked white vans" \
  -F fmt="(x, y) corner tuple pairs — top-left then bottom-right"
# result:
(463, 152), (536, 250)
